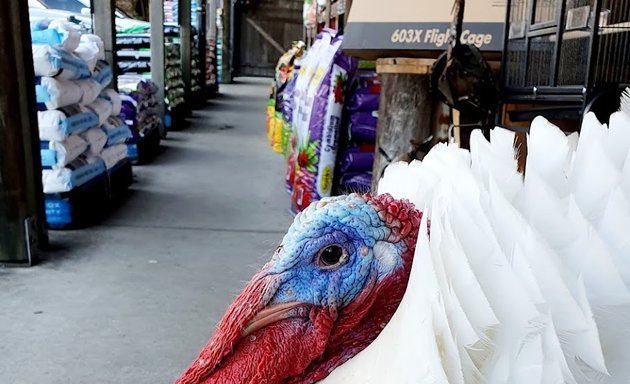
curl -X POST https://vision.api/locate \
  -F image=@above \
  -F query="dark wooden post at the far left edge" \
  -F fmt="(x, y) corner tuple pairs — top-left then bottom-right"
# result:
(0, 1), (48, 264)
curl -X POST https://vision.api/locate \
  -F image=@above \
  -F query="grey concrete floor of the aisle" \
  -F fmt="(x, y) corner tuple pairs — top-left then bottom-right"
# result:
(0, 79), (292, 384)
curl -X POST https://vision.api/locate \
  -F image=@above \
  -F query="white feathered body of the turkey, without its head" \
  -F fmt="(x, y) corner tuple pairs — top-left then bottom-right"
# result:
(322, 90), (630, 384)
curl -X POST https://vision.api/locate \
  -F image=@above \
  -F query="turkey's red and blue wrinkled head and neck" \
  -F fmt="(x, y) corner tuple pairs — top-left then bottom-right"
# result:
(177, 194), (421, 384)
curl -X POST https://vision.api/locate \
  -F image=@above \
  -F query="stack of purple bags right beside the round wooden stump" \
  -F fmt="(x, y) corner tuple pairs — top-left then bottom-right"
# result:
(336, 70), (381, 193)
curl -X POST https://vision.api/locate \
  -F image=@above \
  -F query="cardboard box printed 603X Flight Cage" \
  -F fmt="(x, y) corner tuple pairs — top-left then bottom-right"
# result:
(343, 0), (507, 59)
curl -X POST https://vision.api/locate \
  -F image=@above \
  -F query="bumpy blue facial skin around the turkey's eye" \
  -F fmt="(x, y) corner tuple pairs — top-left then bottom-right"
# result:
(267, 195), (406, 308)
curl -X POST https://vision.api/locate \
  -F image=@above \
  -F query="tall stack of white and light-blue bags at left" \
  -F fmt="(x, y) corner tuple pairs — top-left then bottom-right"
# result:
(31, 20), (131, 227)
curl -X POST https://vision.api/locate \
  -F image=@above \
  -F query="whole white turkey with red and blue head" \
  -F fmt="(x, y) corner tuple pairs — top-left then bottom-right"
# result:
(177, 90), (630, 384)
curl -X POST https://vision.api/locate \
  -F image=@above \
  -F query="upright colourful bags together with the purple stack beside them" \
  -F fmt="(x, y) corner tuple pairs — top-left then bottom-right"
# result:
(267, 30), (380, 212)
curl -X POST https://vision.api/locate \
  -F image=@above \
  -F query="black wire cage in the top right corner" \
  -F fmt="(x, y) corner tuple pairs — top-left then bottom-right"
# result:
(502, 0), (630, 120)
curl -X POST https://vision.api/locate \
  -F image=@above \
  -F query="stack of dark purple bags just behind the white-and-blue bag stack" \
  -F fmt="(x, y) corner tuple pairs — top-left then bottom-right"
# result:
(118, 75), (163, 163)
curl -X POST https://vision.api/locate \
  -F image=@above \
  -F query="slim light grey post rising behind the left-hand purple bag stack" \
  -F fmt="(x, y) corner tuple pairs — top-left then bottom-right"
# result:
(149, 0), (165, 136)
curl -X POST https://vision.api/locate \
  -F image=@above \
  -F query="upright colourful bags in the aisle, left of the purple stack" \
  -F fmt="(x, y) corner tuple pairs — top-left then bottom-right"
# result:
(267, 30), (357, 212)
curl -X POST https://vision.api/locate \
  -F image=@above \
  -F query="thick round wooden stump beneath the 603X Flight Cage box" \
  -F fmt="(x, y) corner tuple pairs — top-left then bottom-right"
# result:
(372, 58), (434, 191)
